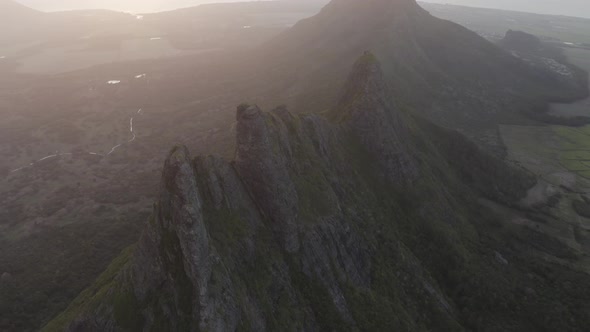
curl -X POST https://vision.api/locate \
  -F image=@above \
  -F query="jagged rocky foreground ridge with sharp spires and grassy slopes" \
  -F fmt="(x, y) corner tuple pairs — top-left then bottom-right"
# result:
(45, 54), (590, 331)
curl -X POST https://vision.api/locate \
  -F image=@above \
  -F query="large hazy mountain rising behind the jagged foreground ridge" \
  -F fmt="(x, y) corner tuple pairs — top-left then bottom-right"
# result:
(265, 0), (587, 152)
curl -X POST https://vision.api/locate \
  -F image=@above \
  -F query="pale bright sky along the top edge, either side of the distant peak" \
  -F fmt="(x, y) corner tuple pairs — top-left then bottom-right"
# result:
(17, 0), (590, 18)
